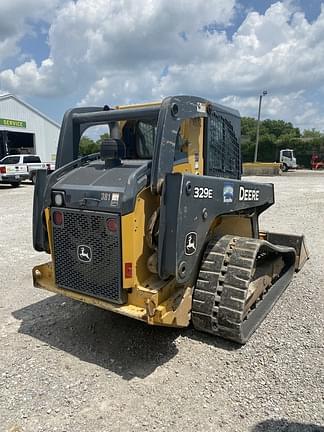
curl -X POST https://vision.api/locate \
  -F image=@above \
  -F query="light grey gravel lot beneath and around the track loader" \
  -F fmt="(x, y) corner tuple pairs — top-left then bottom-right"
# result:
(0, 172), (324, 432)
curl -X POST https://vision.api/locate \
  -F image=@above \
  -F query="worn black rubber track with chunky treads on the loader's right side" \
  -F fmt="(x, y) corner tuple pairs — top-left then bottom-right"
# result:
(192, 235), (295, 344)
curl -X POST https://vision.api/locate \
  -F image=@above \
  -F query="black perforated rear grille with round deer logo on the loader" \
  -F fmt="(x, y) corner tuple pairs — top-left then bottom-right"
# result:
(52, 208), (124, 304)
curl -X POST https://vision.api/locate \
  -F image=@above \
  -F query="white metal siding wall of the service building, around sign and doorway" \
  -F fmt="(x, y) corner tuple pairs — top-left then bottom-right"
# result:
(0, 99), (60, 162)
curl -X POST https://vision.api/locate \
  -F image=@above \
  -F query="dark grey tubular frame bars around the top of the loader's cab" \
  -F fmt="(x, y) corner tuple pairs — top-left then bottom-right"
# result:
(56, 96), (239, 193)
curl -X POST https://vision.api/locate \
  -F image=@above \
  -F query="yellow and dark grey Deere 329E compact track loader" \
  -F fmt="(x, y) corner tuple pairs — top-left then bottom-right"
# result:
(33, 96), (308, 343)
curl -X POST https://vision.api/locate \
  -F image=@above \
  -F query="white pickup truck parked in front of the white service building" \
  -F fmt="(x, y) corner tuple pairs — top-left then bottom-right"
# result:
(0, 154), (55, 187)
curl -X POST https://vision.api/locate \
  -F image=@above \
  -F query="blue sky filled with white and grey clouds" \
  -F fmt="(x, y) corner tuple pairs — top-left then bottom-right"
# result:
(0, 0), (324, 131)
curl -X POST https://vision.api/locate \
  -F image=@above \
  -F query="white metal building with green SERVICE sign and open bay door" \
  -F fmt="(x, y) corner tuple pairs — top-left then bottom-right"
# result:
(0, 94), (60, 162)
